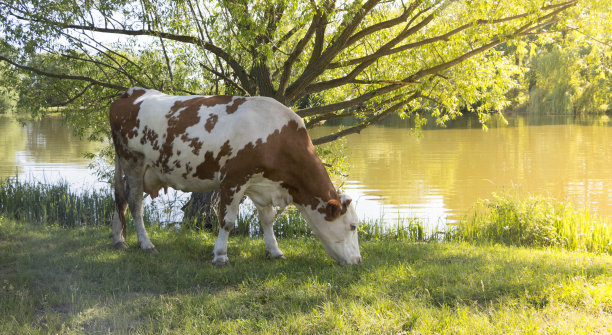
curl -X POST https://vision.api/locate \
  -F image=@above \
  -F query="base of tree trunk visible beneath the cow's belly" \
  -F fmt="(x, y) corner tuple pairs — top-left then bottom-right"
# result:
(181, 191), (219, 230)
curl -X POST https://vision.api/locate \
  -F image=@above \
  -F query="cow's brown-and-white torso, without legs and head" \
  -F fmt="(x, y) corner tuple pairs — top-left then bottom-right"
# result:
(110, 88), (324, 196)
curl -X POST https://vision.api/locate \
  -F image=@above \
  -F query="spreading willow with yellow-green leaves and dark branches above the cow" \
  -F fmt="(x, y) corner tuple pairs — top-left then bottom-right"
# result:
(0, 0), (578, 144)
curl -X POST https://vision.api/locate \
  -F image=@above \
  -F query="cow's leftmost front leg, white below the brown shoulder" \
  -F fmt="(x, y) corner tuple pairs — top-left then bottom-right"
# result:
(212, 189), (244, 267)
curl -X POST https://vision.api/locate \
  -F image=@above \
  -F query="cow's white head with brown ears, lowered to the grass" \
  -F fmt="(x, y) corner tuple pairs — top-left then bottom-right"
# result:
(303, 194), (361, 265)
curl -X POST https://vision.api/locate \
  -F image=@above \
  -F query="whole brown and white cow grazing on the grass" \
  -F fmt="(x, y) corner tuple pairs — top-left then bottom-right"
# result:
(110, 88), (361, 266)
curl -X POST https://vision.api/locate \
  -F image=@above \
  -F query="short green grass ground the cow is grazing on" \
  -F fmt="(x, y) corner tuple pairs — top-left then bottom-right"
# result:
(0, 219), (612, 334)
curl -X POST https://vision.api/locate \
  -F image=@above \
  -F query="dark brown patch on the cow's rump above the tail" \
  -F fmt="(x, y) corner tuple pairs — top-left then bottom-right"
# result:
(109, 89), (146, 160)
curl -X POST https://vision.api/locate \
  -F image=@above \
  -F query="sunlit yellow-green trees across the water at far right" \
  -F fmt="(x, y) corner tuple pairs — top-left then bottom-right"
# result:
(506, 0), (612, 115)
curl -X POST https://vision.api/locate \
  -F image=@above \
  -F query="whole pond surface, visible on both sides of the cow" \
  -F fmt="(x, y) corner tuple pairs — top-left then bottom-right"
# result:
(0, 115), (612, 226)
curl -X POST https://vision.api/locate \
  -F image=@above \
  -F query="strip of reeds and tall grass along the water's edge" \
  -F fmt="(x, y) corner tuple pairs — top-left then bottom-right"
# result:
(0, 178), (612, 255)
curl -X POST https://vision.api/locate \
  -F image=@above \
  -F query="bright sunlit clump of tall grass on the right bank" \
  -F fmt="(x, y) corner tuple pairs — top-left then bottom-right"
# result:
(451, 194), (612, 254)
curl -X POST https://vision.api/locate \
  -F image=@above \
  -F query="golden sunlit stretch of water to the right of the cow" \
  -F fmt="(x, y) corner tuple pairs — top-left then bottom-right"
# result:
(311, 116), (612, 226)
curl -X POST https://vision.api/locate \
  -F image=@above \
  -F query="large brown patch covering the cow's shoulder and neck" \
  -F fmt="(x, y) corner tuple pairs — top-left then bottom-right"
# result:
(220, 121), (340, 217)
